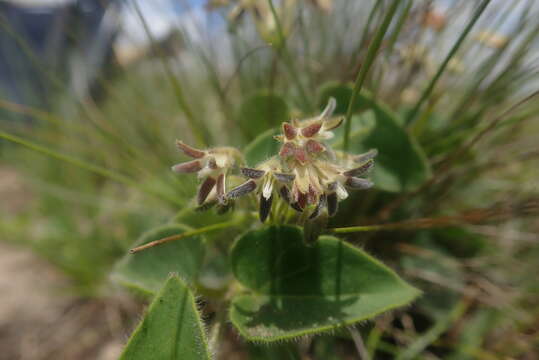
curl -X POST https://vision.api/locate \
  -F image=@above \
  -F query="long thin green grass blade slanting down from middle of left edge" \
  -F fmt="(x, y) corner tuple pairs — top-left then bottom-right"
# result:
(0, 131), (184, 206)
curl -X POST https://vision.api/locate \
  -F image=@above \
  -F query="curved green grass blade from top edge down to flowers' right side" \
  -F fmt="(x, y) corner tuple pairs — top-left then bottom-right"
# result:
(343, 0), (400, 151)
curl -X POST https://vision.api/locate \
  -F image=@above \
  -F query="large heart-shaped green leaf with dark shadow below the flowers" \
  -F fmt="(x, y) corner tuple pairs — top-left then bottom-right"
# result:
(230, 226), (419, 342)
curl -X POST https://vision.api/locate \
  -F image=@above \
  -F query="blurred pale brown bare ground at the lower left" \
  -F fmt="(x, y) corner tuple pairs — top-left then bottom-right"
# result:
(0, 166), (135, 360)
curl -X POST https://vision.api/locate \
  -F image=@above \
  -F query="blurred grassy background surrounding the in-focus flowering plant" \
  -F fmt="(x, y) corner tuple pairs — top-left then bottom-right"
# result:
(0, 0), (539, 360)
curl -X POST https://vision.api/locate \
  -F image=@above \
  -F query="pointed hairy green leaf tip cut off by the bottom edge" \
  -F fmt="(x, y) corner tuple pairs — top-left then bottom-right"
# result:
(120, 275), (211, 360)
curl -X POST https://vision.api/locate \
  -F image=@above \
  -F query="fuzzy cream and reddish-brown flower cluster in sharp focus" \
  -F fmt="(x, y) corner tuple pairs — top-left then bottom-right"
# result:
(173, 98), (377, 222)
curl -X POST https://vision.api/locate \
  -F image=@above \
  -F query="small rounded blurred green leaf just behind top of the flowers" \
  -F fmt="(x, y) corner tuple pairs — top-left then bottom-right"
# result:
(238, 92), (289, 139)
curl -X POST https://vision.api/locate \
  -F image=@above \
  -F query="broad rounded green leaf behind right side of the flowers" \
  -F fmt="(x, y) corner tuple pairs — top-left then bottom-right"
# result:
(320, 84), (432, 192)
